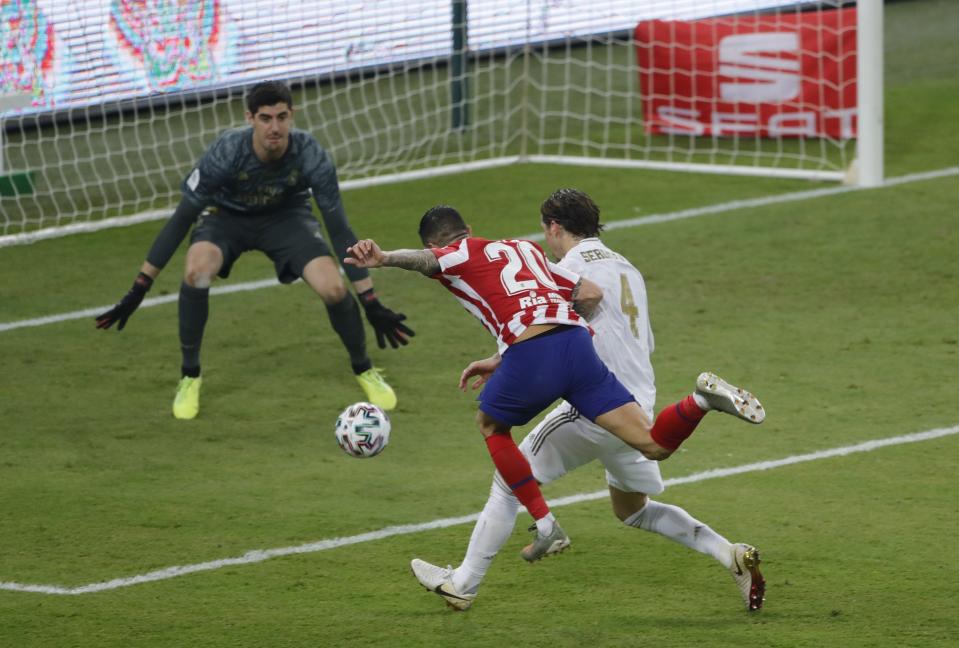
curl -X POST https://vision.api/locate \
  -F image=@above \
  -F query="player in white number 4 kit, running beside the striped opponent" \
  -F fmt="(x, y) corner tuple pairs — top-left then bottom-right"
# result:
(411, 189), (765, 611)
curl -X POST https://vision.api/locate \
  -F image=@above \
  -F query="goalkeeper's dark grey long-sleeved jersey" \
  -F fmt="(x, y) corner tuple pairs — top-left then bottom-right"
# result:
(147, 127), (369, 281)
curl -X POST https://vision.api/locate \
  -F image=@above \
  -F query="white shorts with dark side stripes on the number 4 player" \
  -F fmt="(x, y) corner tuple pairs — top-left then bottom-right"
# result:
(519, 401), (665, 495)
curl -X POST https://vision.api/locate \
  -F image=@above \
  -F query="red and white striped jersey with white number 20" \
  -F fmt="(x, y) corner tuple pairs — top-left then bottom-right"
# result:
(431, 237), (589, 354)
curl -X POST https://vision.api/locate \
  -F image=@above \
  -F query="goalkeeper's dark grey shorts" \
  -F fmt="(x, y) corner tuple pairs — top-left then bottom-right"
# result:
(190, 206), (331, 283)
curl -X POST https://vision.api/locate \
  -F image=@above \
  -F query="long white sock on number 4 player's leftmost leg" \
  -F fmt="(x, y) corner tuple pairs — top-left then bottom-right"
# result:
(453, 474), (519, 594)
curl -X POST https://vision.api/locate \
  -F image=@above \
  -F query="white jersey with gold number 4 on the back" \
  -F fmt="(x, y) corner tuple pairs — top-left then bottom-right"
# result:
(559, 238), (656, 412)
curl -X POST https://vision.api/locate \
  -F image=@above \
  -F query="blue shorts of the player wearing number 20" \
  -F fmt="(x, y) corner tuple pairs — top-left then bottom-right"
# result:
(478, 326), (636, 425)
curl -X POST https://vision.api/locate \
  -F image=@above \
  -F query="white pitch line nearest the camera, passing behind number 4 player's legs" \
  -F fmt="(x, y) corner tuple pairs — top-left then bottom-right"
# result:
(0, 425), (959, 595)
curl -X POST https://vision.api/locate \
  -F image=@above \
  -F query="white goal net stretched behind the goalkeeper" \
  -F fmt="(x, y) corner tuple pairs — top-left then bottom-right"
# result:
(0, 0), (881, 245)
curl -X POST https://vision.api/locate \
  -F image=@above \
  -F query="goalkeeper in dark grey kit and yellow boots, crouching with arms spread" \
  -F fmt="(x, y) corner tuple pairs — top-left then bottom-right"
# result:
(96, 81), (414, 419)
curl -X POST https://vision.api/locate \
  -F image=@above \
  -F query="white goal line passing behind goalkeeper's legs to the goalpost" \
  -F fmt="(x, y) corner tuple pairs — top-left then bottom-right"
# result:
(0, 167), (959, 333)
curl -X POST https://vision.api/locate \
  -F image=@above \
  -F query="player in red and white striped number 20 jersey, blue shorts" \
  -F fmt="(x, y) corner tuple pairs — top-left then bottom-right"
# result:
(344, 205), (728, 562)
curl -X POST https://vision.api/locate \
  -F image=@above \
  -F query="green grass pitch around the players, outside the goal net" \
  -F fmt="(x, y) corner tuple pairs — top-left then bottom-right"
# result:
(0, 0), (959, 648)
